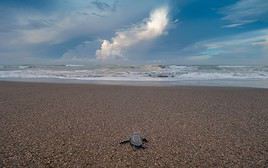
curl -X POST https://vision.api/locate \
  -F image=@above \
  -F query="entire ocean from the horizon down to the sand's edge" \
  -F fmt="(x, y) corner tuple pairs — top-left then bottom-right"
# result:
(0, 64), (268, 88)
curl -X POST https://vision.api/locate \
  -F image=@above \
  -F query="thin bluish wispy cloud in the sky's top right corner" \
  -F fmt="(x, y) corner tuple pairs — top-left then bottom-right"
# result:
(220, 0), (268, 28)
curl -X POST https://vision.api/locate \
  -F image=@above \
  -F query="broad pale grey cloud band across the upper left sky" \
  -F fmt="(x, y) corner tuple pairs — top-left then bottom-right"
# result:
(5, 0), (160, 46)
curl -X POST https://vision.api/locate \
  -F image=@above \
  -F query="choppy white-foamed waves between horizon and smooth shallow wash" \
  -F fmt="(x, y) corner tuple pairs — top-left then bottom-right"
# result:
(0, 64), (268, 82)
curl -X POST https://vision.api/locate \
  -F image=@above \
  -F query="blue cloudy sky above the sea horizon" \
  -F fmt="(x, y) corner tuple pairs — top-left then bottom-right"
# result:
(0, 0), (268, 65)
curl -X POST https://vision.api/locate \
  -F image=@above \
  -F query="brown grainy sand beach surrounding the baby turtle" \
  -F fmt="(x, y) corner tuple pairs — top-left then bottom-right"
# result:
(0, 82), (268, 167)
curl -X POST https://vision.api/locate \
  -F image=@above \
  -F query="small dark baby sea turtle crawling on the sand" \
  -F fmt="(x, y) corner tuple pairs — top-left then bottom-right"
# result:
(120, 132), (148, 149)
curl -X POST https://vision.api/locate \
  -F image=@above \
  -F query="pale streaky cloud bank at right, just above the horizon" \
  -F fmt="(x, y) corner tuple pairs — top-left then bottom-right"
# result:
(180, 29), (268, 64)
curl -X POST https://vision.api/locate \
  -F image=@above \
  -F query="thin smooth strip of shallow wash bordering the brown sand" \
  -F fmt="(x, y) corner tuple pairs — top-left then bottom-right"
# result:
(0, 78), (268, 89)
